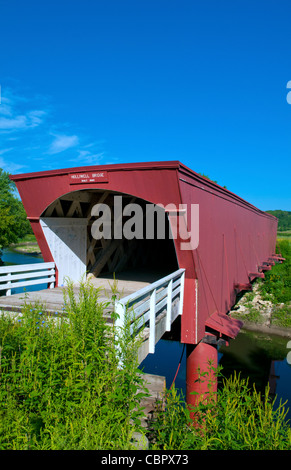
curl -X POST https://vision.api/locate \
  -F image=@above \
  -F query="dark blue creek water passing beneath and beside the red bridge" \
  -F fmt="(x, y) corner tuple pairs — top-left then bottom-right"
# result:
(2, 249), (291, 422)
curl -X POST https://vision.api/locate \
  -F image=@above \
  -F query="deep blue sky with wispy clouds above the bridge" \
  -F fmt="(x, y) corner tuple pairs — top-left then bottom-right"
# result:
(0, 0), (291, 210)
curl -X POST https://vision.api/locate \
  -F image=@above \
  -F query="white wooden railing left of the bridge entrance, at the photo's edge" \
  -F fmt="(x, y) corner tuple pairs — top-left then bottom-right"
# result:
(0, 262), (56, 295)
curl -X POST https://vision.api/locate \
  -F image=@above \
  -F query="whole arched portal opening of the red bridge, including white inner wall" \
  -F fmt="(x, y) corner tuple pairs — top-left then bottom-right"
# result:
(40, 189), (179, 285)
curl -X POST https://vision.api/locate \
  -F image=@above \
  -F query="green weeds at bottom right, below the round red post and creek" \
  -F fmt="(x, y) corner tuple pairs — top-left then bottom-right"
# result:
(151, 373), (291, 450)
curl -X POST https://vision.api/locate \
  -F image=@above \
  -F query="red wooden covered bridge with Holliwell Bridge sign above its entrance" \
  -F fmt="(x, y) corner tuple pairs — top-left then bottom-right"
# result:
(0, 161), (279, 401)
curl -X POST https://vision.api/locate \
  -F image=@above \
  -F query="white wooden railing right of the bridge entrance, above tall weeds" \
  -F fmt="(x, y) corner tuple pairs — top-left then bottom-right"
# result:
(115, 269), (185, 353)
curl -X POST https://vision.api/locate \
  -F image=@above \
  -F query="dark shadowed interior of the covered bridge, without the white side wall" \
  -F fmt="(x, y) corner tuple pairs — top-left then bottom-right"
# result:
(42, 190), (179, 282)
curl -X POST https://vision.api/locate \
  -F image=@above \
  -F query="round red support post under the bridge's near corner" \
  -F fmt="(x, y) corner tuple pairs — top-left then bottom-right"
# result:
(186, 342), (218, 414)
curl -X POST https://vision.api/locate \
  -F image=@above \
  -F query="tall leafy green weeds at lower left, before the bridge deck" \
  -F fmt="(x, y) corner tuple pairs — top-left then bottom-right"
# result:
(0, 282), (146, 450)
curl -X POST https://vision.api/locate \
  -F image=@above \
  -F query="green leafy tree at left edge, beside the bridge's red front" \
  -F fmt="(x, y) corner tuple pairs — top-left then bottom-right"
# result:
(0, 168), (32, 249)
